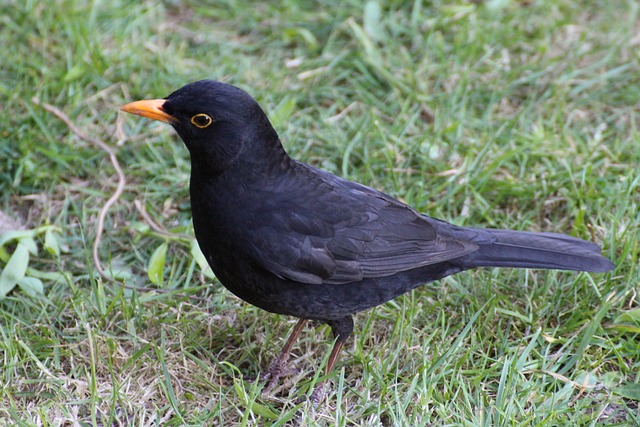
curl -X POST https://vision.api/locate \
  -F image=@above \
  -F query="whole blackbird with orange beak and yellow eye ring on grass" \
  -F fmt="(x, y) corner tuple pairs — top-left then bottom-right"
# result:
(121, 80), (614, 402)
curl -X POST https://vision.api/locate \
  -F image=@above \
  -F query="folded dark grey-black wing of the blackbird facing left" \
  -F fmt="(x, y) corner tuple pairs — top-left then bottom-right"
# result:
(245, 165), (478, 284)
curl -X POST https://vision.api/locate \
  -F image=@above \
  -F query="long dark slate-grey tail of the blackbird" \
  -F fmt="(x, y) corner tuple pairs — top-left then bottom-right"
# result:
(454, 228), (615, 272)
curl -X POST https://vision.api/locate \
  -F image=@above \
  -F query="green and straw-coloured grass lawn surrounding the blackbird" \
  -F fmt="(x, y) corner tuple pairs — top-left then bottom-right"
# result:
(0, 0), (640, 426)
